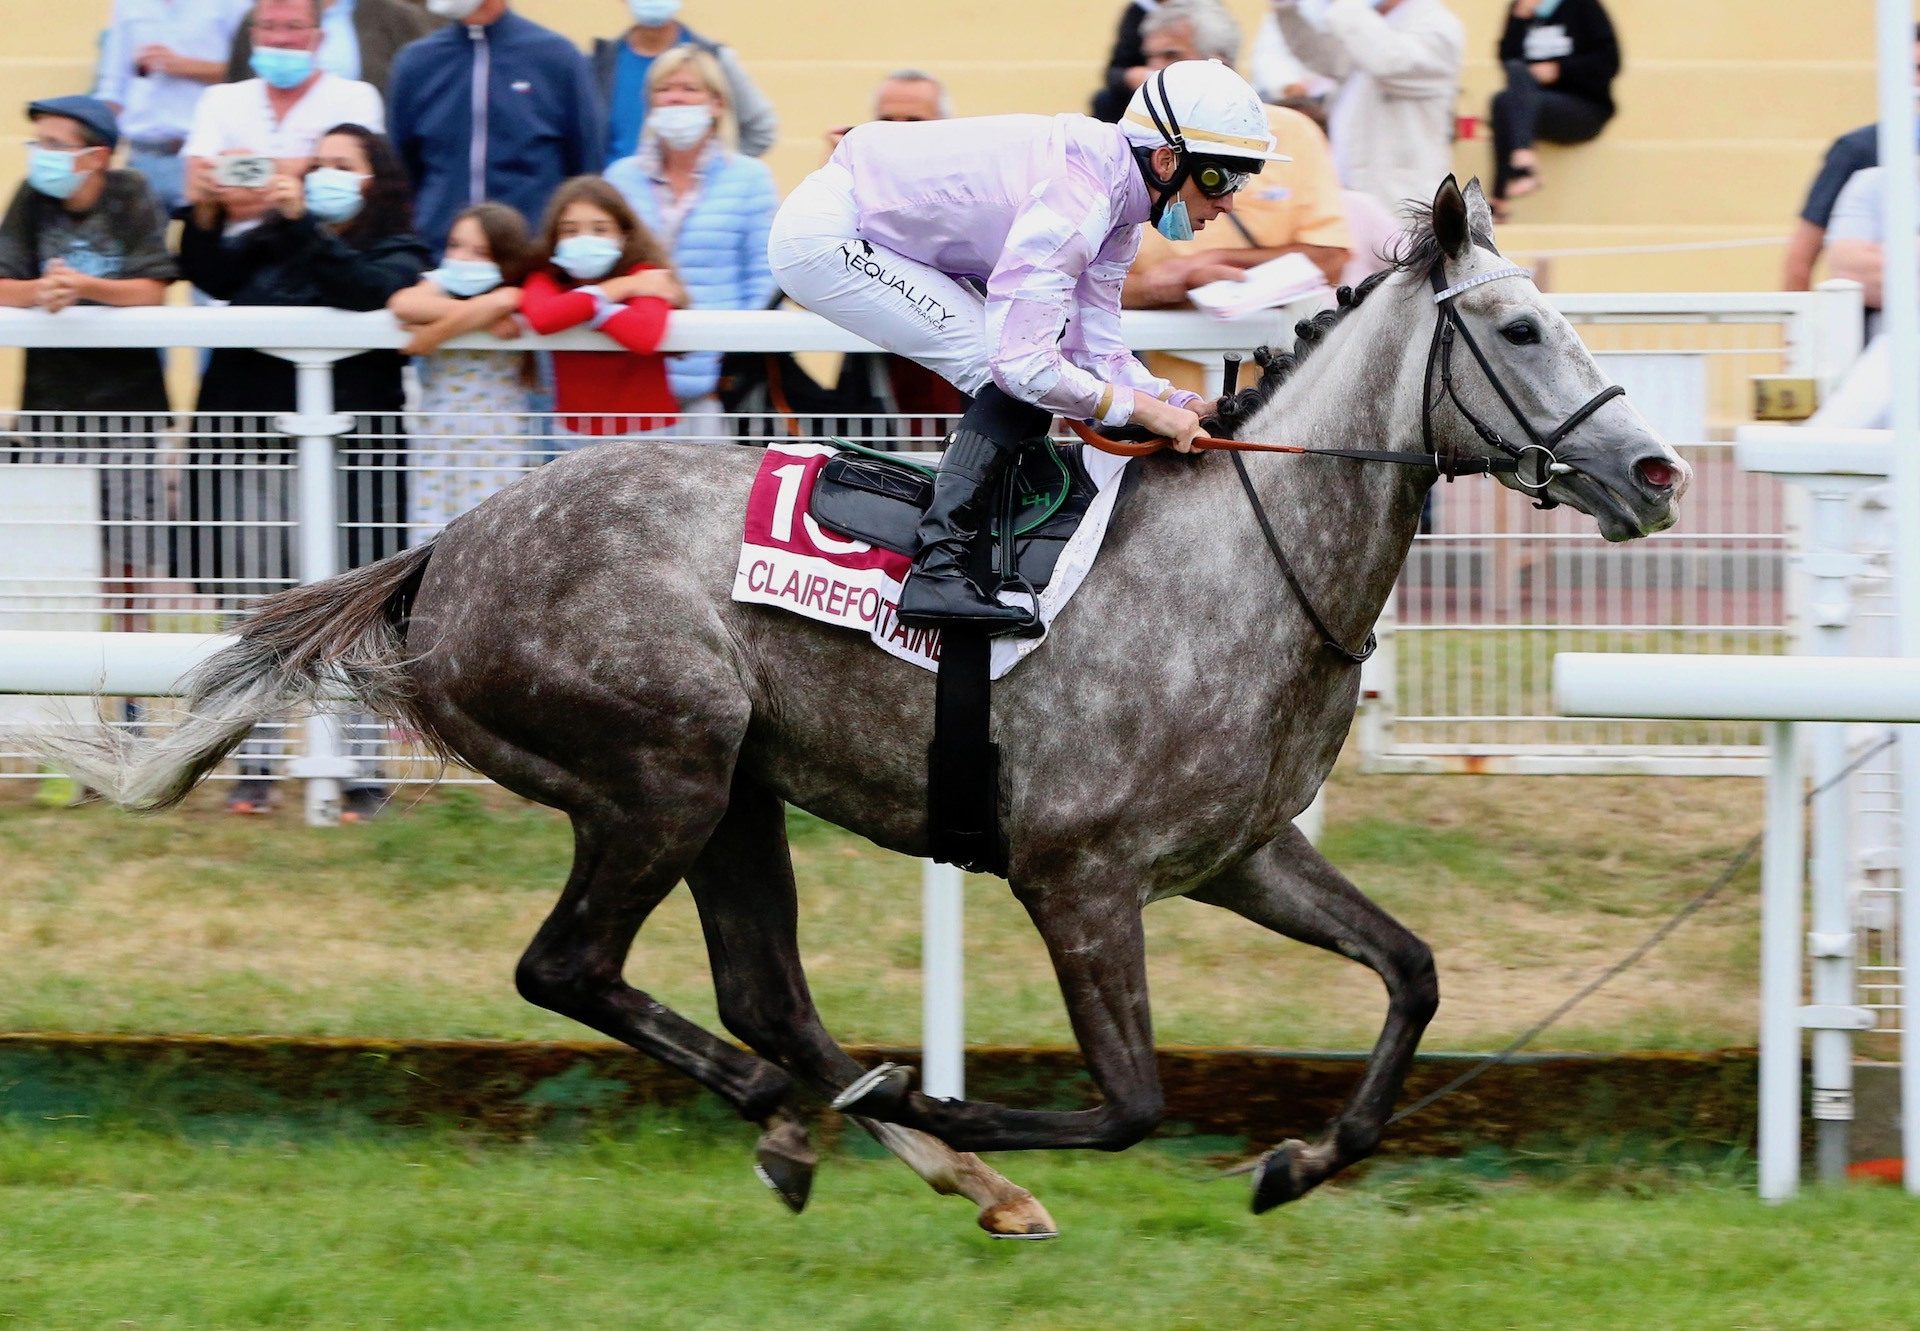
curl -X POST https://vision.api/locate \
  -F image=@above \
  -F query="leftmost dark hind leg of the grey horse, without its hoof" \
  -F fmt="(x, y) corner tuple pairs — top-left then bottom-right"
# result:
(515, 795), (793, 1122)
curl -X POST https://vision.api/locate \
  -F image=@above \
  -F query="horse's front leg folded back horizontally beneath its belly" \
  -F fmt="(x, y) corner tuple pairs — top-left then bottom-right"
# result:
(833, 883), (1164, 1150)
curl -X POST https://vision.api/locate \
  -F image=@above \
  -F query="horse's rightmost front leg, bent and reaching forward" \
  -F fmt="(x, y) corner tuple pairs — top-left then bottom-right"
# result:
(1187, 826), (1440, 1214)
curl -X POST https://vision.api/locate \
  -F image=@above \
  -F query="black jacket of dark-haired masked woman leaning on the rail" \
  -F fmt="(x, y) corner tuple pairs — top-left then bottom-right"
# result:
(180, 213), (434, 413)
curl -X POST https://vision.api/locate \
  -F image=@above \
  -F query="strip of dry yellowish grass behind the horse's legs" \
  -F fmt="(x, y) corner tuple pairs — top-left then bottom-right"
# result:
(0, 772), (1761, 1051)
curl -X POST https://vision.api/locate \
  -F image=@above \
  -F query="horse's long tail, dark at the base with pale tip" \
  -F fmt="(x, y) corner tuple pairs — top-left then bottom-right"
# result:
(40, 544), (434, 811)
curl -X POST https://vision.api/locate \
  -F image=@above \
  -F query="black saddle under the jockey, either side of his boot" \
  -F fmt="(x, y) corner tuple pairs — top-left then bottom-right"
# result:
(808, 440), (1098, 592)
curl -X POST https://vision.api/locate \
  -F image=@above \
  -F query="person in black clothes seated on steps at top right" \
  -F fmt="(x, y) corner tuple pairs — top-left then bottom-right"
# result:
(1490, 0), (1620, 219)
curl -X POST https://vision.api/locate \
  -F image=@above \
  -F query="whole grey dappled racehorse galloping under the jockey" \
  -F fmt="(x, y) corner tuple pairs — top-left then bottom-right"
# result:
(48, 179), (1688, 1237)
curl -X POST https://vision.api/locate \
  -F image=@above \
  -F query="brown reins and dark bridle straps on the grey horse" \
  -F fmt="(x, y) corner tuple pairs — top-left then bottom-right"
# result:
(1068, 253), (1626, 665)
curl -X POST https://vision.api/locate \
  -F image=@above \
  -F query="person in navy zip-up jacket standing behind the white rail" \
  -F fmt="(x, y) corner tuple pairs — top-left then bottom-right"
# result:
(390, 0), (603, 254)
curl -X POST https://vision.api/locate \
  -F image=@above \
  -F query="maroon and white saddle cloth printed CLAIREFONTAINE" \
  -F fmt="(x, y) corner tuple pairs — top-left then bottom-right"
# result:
(733, 442), (1127, 680)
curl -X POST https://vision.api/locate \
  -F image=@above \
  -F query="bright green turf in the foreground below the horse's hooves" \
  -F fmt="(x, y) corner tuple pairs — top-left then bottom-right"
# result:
(0, 1124), (1920, 1331)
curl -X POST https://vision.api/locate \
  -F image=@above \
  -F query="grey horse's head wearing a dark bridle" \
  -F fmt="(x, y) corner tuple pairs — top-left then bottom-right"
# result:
(1411, 175), (1693, 542)
